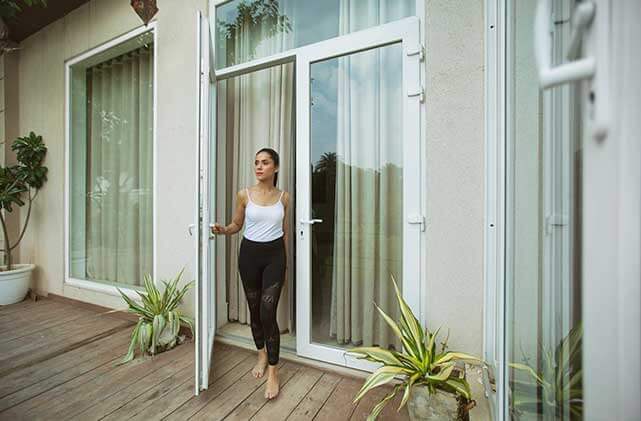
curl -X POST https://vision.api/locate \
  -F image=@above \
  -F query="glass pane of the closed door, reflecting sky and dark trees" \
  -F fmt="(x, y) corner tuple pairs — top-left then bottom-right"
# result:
(310, 44), (403, 349)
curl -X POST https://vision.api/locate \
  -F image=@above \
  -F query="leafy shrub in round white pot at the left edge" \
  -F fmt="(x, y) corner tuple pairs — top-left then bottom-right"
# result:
(0, 132), (47, 305)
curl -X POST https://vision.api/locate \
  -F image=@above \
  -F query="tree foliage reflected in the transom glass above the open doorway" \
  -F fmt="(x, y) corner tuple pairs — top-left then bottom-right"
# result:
(216, 0), (292, 65)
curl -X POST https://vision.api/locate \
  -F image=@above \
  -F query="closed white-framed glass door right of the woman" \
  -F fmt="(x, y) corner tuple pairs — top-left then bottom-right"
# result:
(296, 18), (425, 370)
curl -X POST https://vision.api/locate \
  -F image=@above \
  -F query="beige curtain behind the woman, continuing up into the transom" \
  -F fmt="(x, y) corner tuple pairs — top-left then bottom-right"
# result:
(223, 7), (295, 331)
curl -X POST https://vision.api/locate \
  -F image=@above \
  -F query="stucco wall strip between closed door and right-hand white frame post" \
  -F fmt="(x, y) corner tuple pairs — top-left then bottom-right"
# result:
(425, 0), (485, 355)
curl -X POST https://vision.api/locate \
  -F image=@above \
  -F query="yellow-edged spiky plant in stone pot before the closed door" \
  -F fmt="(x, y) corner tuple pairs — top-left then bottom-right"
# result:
(347, 277), (481, 420)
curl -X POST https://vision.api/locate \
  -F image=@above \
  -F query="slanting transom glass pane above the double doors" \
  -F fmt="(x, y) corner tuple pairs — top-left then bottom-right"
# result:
(216, 0), (416, 69)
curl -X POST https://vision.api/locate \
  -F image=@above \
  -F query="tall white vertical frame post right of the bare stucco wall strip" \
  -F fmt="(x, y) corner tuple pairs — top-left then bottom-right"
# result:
(483, 0), (508, 419)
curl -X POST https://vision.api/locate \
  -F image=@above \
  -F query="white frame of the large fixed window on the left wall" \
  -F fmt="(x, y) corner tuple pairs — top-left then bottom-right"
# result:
(64, 21), (158, 300)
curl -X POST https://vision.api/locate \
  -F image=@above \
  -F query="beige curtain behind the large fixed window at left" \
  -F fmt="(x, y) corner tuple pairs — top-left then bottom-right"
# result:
(86, 47), (153, 285)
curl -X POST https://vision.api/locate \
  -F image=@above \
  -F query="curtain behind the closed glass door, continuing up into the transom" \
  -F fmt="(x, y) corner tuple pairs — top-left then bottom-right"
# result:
(330, 0), (413, 349)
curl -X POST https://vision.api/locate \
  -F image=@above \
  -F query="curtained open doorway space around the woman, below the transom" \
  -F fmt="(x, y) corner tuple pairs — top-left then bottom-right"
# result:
(212, 63), (296, 348)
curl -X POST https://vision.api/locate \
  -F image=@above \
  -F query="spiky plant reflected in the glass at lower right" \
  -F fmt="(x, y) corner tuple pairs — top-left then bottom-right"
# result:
(510, 324), (583, 419)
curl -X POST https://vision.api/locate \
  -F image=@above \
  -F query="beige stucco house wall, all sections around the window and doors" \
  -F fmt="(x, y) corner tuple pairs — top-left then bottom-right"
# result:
(7, 0), (484, 354)
